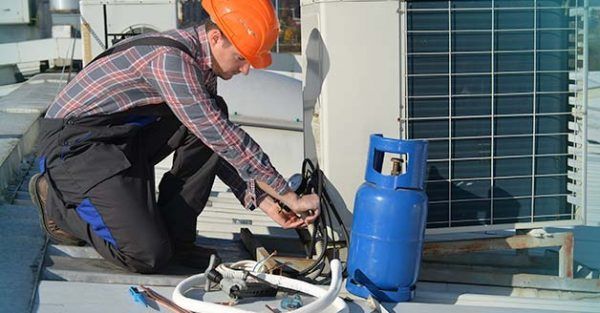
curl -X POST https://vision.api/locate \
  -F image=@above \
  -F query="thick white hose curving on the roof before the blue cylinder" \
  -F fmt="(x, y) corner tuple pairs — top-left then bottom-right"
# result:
(173, 260), (349, 313)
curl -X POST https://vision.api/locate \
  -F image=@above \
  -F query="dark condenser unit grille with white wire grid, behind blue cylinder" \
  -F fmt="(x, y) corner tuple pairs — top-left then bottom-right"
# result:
(404, 0), (579, 228)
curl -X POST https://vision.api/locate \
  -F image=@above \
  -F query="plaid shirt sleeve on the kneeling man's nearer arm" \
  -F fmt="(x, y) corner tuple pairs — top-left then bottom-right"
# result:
(142, 48), (288, 206)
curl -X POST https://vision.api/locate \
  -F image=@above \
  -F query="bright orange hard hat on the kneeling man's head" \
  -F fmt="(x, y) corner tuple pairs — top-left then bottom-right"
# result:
(202, 0), (279, 68)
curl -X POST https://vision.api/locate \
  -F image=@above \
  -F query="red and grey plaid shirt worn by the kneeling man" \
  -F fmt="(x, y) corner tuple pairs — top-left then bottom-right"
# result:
(46, 26), (289, 209)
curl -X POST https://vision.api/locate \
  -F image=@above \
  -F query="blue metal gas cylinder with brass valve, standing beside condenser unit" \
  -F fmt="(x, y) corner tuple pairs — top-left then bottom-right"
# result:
(346, 134), (427, 302)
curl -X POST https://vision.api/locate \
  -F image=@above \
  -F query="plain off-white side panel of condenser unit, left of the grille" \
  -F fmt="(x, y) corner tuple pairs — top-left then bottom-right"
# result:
(302, 1), (400, 222)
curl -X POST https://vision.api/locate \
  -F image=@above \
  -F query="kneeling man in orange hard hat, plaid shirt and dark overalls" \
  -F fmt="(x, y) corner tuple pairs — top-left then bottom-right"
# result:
(30, 0), (320, 273)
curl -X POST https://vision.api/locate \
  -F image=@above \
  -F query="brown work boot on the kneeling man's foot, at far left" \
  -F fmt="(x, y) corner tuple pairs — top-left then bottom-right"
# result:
(29, 174), (85, 246)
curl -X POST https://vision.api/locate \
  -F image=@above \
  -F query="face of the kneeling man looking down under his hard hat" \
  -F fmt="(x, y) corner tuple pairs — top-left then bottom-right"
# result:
(208, 29), (250, 80)
